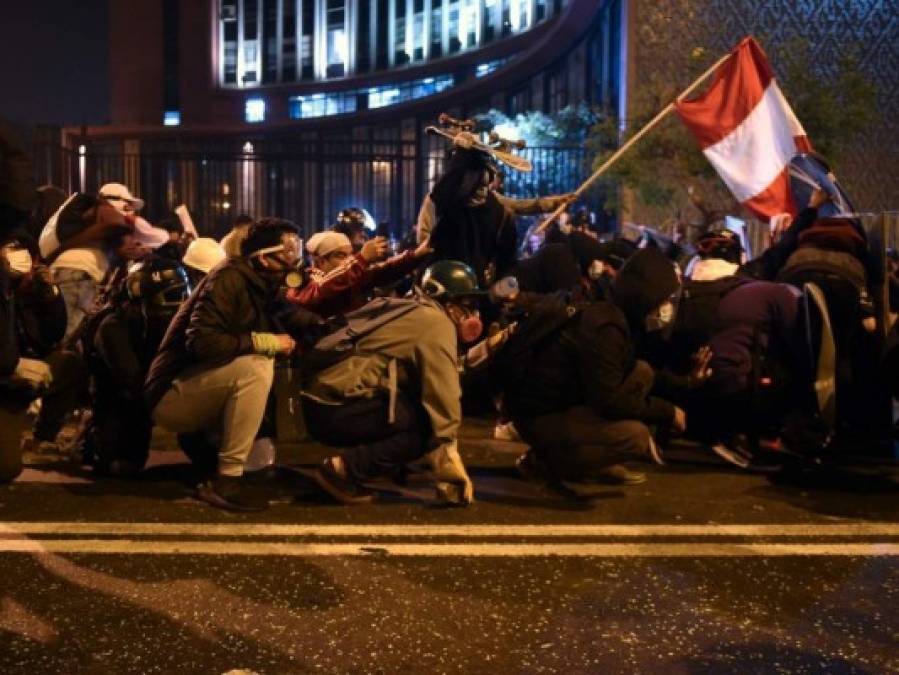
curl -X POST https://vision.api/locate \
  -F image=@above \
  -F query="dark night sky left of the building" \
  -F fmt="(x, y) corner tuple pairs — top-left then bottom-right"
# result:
(0, 0), (110, 126)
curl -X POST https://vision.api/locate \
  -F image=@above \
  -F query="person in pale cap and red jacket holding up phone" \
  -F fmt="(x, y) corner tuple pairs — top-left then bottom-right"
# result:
(286, 230), (431, 317)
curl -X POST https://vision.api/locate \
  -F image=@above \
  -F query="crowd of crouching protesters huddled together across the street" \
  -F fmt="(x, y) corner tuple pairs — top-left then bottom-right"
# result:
(0, 129), (890, 510)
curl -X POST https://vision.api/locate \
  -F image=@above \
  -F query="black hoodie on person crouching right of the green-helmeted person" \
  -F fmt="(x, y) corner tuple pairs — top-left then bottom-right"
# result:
(506, 249), (678, 424)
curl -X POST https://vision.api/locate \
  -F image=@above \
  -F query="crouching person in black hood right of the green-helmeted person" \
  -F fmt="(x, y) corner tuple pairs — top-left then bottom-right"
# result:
(493, 249), (705, 488)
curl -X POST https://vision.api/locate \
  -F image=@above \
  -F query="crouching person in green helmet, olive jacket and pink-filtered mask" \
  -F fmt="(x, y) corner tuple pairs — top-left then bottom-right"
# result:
(303, 261), (483, 504)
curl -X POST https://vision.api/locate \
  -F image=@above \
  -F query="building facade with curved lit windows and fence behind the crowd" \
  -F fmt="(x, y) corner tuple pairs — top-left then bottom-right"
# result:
(48, 0), (623, 234)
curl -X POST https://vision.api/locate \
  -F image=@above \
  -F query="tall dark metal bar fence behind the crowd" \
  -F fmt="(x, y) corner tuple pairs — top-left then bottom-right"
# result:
(34, 139), (589, 237)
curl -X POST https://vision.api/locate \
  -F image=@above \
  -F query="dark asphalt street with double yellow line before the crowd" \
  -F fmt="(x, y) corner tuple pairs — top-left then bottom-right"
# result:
(0, 420), (899, 674)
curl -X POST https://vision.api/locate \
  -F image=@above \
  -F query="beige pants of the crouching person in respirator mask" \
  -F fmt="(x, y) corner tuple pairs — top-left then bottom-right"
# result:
(153, 354), (275, 476)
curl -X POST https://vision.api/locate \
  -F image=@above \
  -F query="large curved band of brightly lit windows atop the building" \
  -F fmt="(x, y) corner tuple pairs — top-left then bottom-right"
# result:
(216, 0), (540, 87)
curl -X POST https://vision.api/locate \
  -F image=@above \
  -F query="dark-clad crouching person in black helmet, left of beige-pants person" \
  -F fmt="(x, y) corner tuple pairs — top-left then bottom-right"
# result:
(82, 256), (190, 476)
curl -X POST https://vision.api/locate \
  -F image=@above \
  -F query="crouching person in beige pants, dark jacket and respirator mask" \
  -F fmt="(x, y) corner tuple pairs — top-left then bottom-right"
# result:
(144, 218), (318, 511)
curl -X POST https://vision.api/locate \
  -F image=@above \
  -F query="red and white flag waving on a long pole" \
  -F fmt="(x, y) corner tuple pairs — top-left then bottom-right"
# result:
(675, 37), (811, 218)
